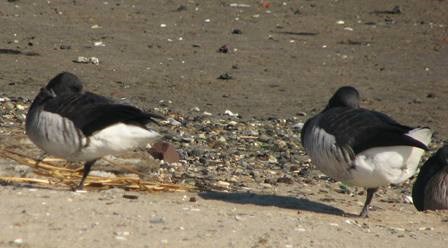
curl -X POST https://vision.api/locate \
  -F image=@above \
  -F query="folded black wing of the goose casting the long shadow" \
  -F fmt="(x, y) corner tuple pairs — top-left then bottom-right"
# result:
(319, 108), (428, 154)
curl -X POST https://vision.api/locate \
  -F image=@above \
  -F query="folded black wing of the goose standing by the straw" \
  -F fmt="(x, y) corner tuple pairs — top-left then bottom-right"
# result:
(44, 92), (164, 136)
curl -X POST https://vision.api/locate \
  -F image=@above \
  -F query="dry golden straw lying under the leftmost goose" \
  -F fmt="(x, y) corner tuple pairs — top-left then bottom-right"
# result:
(0, 149), (194, 192)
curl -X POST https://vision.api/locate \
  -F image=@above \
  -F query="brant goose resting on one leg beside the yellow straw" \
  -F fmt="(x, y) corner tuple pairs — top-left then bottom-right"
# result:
(25, 72), (164, 189)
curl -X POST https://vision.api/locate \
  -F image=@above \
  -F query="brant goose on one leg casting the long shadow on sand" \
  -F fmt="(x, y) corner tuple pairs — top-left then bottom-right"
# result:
(301, 86), (432, 217)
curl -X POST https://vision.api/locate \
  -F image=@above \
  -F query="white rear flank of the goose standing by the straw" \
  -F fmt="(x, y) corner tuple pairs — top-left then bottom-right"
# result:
(76, 123), (161, 161)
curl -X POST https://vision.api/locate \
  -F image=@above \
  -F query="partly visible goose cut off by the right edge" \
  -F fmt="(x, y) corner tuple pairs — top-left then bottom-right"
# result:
(412, 145), (448, 211)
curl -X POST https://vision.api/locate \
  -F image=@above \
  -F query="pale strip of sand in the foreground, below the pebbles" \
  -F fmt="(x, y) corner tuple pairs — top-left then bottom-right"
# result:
(0, 185), (448, 247)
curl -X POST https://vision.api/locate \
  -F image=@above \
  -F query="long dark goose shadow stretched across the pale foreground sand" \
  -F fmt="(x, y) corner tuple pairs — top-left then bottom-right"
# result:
(198, 191), (347, 216)
